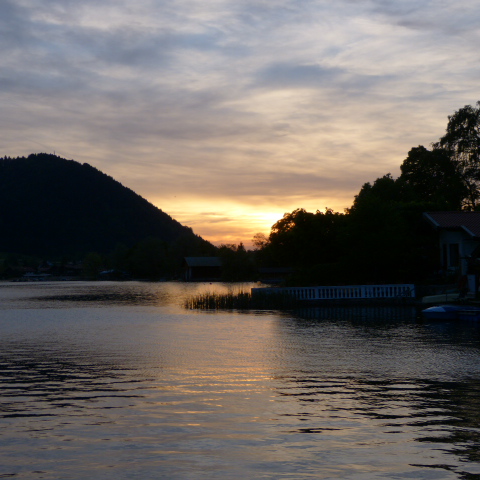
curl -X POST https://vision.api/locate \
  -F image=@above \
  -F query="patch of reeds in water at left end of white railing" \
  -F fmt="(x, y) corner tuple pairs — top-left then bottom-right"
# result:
(185, 291), (299, 310)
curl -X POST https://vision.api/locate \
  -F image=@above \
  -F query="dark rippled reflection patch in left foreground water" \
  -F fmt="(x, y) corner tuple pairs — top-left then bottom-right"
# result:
(0, 342), (140, 418)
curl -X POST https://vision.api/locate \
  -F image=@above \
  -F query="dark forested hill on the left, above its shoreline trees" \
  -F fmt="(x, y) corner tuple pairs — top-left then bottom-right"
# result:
(0, 154), (213, 257)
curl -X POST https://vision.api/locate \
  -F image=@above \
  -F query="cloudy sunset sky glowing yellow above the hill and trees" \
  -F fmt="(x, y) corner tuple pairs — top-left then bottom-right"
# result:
(0, 0), (480, 246)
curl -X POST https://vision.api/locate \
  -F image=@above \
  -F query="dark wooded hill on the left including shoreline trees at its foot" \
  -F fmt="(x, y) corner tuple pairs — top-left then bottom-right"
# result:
(0, 154), (216, 279)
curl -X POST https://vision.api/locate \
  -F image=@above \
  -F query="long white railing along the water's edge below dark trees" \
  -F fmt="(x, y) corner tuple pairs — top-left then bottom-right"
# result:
(252, 284), (415, 300)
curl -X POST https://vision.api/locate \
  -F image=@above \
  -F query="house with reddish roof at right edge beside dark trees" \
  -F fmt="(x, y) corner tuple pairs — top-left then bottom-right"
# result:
(423, 212), (480, 276)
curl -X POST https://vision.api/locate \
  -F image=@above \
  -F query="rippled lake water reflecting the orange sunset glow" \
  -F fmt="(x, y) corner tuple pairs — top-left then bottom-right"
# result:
(0, 282), (480, 480)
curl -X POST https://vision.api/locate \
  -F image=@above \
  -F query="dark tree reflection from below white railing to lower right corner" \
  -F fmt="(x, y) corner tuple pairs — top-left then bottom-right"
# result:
(277, 307), (480, 480)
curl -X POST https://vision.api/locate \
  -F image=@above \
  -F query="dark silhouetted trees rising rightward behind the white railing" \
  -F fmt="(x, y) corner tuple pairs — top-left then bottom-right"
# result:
(253, 102), (480, 285)
